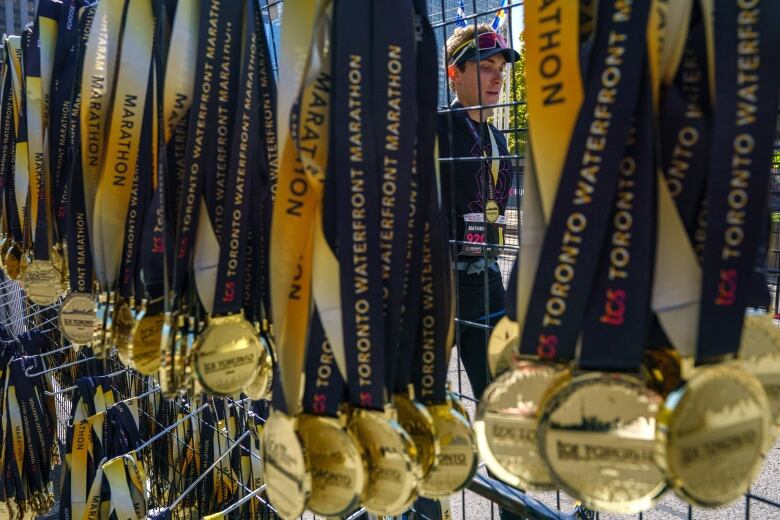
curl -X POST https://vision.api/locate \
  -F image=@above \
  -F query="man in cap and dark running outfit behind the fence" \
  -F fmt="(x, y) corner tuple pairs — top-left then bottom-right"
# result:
(438, 24), (520, 398)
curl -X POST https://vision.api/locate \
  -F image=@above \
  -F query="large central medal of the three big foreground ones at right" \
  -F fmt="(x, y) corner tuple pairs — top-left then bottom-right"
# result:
(538, 373), (666, 514)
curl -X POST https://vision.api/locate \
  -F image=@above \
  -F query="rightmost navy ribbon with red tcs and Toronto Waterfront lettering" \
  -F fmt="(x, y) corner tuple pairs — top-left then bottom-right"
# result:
(696, 2), (780, 363)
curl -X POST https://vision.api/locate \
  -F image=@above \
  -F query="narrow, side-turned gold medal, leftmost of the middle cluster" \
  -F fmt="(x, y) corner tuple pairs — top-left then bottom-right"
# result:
(263, 410), (312, 520)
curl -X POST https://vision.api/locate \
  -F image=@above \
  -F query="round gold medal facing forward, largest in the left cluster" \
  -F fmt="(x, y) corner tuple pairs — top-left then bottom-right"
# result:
(192, 313), (267, 395)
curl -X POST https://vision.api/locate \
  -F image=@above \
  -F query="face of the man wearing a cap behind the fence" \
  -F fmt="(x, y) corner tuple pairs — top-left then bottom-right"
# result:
(452, 53), (506, 106)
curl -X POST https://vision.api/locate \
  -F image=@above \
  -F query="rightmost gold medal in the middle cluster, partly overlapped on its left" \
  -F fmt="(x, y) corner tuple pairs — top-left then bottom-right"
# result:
(419, 401), (479, 498)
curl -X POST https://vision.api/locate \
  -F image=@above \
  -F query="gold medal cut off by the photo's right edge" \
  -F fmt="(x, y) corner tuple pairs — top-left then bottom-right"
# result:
(739, 314), (780, 426)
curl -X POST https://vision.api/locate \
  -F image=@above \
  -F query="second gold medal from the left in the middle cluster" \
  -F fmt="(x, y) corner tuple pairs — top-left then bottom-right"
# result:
(298, 414), (368, 517)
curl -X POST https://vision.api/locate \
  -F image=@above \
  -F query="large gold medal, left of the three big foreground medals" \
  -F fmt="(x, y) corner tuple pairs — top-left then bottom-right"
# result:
(474, 361), (571, 490)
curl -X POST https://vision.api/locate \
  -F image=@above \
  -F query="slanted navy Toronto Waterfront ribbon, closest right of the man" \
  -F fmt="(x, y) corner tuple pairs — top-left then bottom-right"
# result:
(518, 3), (649, 360)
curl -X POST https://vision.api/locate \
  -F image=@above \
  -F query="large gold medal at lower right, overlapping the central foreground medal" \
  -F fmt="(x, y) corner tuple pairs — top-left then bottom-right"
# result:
(656, 361), (771, 507)
